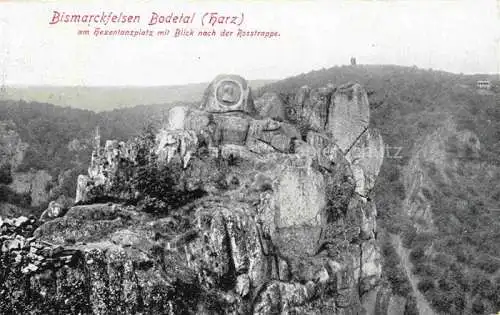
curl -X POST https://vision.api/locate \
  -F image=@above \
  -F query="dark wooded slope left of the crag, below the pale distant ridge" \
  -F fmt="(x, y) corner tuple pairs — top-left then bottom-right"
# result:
(0, 101), (199, 173)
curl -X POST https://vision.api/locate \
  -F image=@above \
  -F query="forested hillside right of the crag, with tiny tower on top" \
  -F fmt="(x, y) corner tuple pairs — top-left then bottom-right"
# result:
(258, 66), (500, 314)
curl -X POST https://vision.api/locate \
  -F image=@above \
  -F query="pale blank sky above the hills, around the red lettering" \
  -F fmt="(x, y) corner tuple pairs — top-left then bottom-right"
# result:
(0, 0), (500, 86)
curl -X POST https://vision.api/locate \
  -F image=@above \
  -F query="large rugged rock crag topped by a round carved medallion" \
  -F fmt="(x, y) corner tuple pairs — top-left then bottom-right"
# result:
(0, 75), (384, 314)
